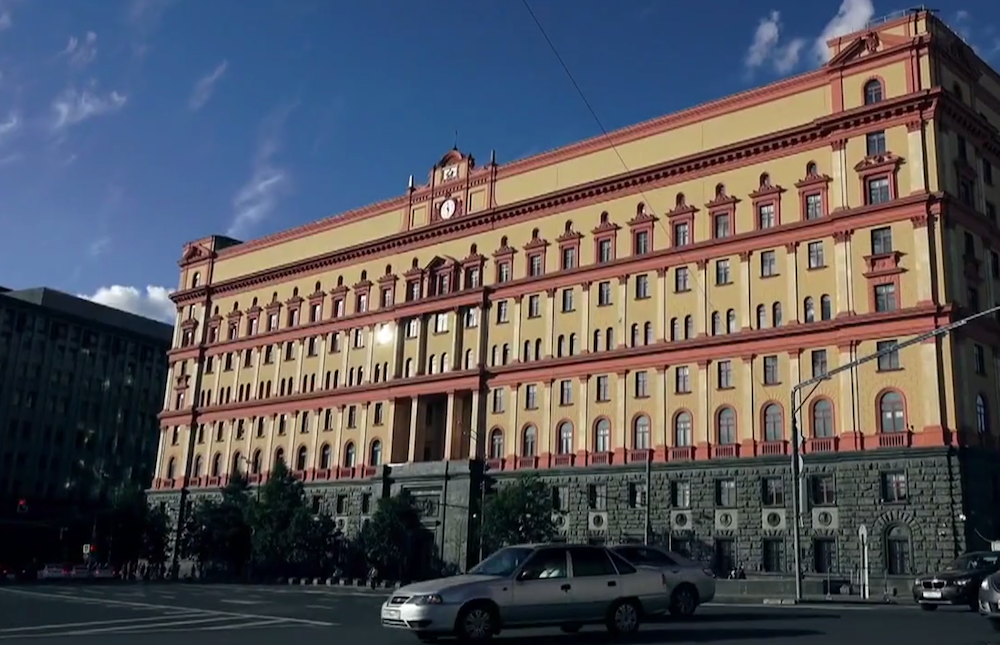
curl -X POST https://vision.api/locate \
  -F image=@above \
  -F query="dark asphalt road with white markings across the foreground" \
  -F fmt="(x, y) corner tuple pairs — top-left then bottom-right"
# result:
(0, 585), (1000, 645)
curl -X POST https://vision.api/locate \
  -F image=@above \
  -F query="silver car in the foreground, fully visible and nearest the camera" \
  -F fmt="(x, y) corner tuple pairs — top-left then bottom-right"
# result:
(381, 544), (671, 642)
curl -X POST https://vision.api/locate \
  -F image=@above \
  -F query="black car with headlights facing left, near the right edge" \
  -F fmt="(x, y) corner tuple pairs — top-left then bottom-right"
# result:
(913, 551), (1000, 611)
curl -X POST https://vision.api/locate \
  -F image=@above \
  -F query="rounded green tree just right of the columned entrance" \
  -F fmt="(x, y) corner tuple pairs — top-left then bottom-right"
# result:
(481, 475), (556, 553)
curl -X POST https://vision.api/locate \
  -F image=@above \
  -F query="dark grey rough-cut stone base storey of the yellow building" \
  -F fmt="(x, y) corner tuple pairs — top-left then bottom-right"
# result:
(149, 448), (1000, 572)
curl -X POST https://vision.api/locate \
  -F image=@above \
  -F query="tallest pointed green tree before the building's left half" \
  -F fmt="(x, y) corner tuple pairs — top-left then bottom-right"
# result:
(250, 462), (334, 575)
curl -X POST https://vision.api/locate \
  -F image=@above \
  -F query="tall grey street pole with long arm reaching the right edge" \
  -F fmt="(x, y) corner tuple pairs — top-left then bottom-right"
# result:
(791, 305), (1000, 600)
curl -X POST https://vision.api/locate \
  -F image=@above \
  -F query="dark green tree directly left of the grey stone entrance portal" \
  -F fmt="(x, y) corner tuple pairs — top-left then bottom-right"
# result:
(358, 490), (423, 580)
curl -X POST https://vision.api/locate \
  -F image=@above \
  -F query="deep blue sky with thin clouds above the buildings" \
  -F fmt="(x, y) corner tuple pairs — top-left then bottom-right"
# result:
(0, 0), (1000, 318)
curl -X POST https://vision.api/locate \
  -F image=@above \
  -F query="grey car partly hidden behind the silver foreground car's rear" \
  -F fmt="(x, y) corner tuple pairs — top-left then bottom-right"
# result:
(611, 544), (715, 618)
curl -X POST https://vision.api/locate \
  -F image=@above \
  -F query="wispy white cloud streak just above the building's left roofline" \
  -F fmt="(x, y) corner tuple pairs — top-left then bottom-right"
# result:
(226, 105), (295, 239)
